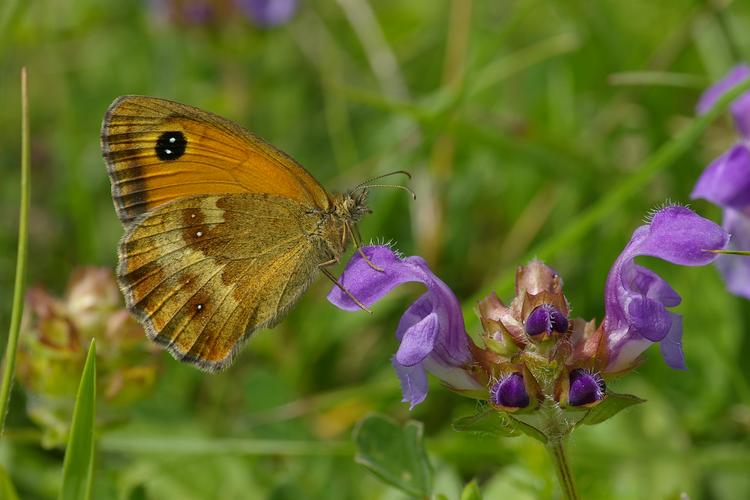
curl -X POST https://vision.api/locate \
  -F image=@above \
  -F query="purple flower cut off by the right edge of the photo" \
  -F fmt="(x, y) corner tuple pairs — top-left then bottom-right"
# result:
(690, 65), (750, 299)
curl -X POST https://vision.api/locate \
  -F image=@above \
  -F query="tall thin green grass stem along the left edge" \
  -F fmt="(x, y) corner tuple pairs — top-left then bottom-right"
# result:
(0, 68), (30, 435)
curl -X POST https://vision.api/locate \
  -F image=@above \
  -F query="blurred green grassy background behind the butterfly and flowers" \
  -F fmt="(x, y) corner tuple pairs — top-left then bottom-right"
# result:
(0, 0), (750, 499)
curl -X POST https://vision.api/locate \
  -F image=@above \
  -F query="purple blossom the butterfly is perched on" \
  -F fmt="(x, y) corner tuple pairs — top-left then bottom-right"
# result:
(328, 246), (484, 408)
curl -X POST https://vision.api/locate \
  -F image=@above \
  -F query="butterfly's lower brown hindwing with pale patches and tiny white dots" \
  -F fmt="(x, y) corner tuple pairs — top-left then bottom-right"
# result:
(118, 194), (329, 371)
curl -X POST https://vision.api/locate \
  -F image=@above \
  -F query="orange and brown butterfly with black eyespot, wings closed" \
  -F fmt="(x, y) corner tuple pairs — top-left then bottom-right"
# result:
(101, 96), (413, 372)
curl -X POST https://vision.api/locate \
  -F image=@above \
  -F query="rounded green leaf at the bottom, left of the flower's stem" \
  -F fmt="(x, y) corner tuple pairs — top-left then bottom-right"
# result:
(354, 415), (432, 497)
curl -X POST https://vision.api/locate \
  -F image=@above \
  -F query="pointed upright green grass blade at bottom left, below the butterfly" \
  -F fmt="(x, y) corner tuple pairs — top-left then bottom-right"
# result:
(59, 339), (96, 500)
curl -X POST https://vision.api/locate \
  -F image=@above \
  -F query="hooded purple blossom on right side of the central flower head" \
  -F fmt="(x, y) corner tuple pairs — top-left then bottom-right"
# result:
(604, 206), (729, 373)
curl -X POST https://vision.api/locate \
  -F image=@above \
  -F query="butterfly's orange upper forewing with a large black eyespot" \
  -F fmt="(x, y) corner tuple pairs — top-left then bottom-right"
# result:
(101, 96), (331, 227)
